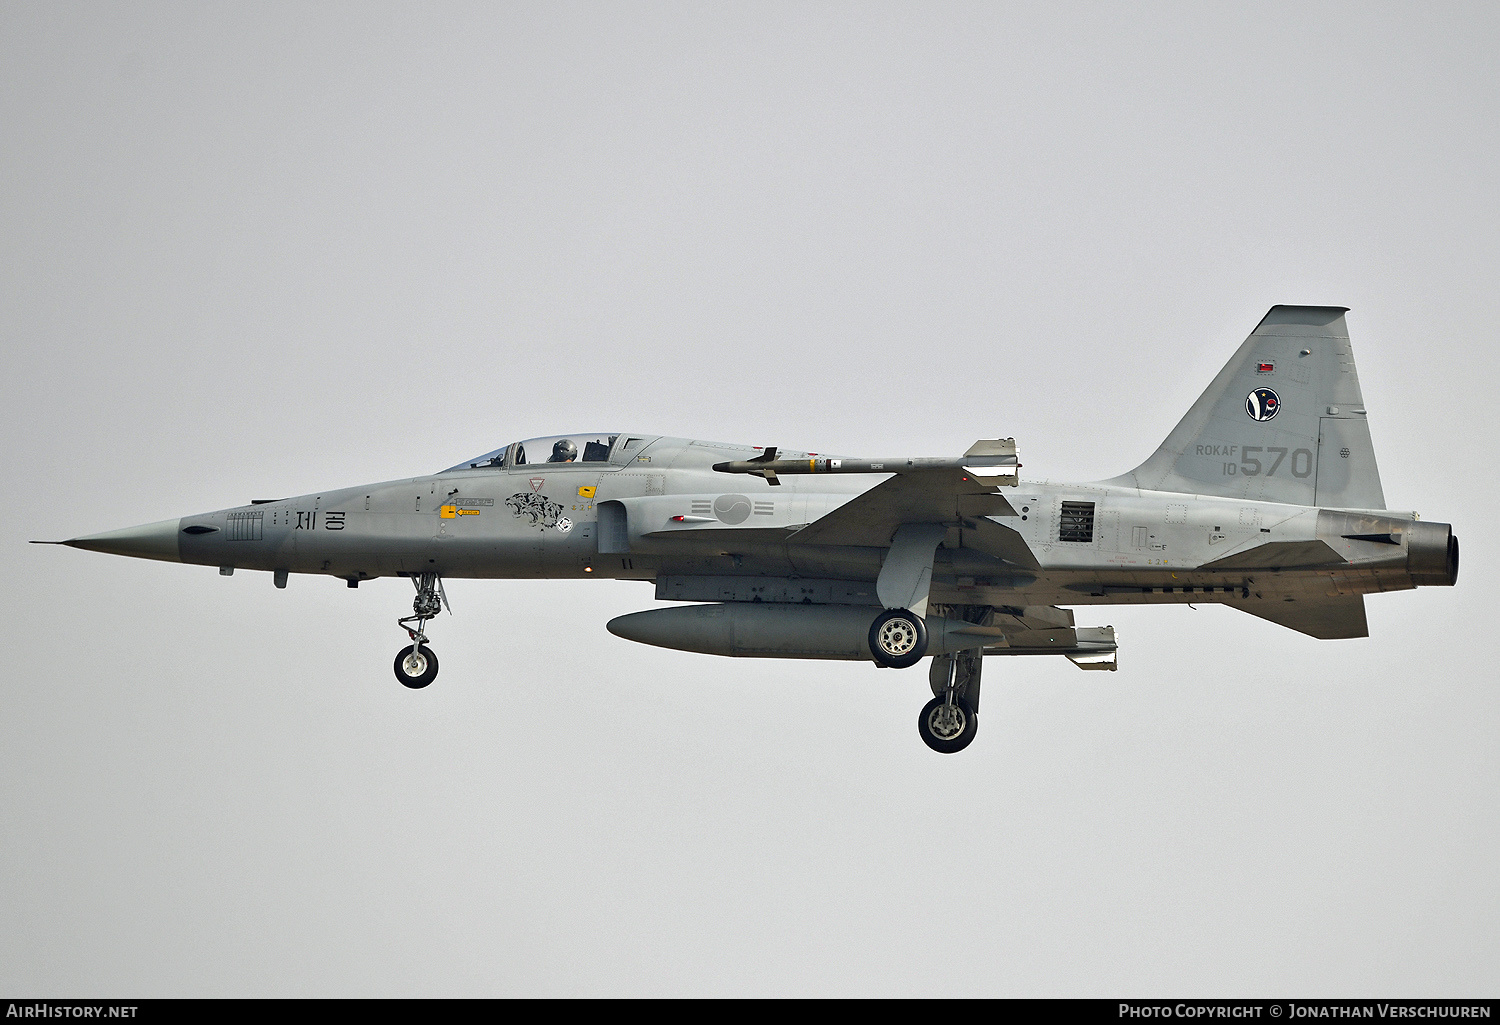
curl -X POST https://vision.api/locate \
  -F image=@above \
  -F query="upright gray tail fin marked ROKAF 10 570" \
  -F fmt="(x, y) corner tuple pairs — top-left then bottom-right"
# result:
(1107, 306), (1386, 509)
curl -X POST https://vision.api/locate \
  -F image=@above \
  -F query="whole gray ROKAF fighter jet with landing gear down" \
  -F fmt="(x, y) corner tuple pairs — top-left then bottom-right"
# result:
(51, 306), (1458, 752)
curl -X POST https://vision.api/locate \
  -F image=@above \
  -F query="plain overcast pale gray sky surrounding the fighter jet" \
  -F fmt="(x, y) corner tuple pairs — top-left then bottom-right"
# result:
(0, 2), (1500, 996)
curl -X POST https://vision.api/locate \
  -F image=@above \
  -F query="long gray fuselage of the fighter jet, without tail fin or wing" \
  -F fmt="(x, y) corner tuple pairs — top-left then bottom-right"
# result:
(126, 435), (1457, 618)
